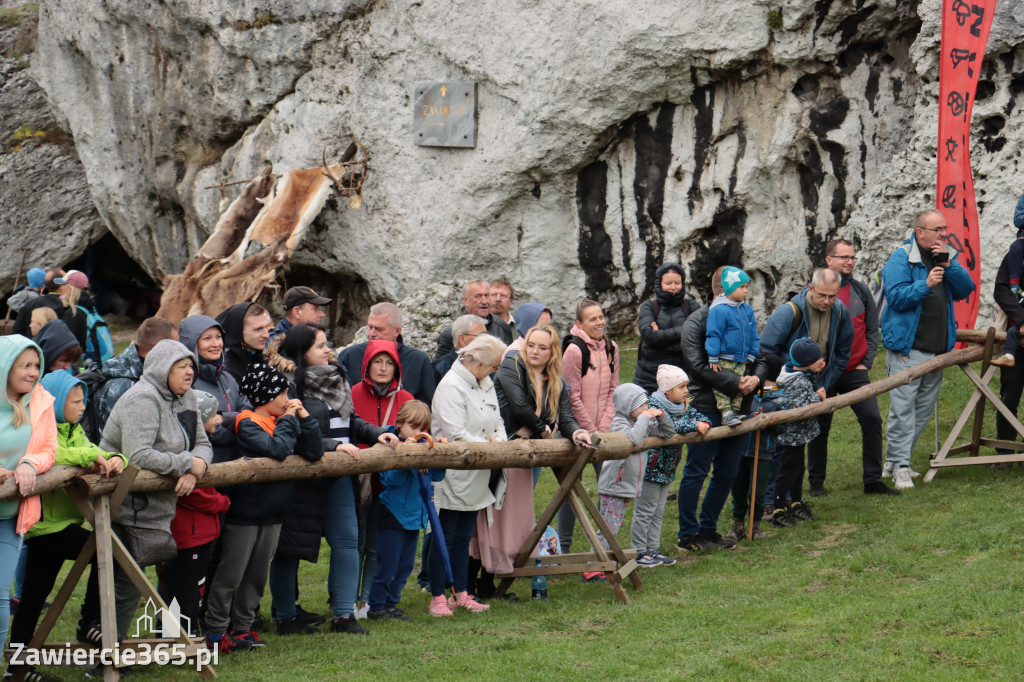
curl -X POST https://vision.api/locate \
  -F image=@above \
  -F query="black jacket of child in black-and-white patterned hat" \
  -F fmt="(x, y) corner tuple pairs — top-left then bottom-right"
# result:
(226, 416), (324, 525)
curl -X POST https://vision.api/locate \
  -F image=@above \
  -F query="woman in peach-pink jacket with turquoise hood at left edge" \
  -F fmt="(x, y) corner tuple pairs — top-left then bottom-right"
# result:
(0, 334), (57, 644)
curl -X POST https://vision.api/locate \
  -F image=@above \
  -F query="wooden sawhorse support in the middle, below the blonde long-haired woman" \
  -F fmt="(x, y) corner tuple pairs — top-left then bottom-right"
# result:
(495, 449), (643, 603)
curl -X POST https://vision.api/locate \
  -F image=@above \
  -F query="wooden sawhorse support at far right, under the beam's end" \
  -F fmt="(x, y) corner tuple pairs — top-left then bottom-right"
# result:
(925, 327), (1024, 482)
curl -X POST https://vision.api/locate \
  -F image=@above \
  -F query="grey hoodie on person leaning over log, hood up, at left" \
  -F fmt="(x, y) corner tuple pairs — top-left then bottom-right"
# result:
(99, 339), (213, 531)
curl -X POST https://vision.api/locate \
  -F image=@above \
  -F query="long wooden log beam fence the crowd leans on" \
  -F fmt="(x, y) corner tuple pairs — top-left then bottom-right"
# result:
(0, 339), (999, 500)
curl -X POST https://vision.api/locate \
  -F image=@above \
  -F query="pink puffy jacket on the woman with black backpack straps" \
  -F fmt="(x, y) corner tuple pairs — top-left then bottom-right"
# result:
(562, 325), (618, 432)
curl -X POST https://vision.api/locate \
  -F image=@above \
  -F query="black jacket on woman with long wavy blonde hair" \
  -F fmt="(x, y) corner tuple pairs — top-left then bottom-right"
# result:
(495, 353), (580, 438)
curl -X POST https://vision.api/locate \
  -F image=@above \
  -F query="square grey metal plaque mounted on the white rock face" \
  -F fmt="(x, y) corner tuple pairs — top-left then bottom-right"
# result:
(413, 82), (476, 146)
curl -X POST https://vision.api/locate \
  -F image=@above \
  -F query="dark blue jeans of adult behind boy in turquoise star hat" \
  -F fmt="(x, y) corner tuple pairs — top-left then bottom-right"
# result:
(679, 412), (748, 540)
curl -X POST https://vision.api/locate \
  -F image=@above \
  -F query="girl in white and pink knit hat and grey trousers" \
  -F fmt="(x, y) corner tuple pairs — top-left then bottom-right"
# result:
(631, 365), (711, 568)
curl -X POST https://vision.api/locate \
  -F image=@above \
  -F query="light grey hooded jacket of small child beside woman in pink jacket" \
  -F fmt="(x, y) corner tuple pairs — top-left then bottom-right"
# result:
(597, 384), (676, 498)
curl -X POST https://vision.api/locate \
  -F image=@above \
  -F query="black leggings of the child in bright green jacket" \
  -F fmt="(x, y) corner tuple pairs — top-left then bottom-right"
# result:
(10, 525), (99, 644)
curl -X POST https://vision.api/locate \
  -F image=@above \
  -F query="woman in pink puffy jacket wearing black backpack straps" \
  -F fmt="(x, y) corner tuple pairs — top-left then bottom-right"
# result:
(558, 299), (618, 557)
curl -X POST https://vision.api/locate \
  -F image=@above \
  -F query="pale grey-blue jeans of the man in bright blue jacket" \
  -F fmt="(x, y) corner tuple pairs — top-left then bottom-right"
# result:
(886, 350), (942, 468)
